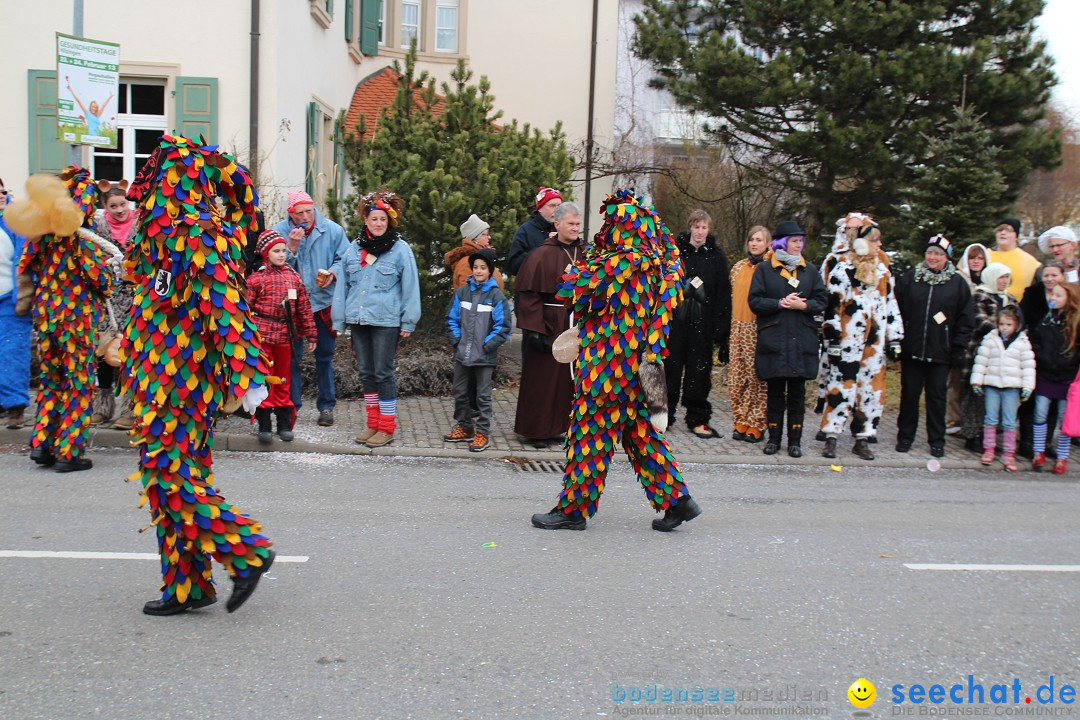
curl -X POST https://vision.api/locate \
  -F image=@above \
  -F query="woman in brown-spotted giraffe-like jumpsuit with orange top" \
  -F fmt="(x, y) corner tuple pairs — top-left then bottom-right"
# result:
(728, 225), (772, 443)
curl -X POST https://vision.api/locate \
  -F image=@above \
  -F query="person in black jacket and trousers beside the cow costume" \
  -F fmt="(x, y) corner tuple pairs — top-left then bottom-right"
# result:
(896, 235), (971, 458)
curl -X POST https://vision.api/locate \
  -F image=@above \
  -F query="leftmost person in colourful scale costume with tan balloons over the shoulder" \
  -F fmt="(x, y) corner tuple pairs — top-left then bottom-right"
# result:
(4, 165), (120, 473)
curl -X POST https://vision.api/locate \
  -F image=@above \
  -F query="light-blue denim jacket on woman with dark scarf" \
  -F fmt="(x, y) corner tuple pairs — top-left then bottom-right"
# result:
(332, 236), (420, 332)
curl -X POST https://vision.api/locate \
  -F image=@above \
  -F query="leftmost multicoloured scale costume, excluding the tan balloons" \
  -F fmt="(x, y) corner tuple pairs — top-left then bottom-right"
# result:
(18, 165), (119, 462)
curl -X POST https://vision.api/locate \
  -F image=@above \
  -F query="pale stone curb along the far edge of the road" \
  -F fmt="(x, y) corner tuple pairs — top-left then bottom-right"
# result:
(0, 427), (996, 472)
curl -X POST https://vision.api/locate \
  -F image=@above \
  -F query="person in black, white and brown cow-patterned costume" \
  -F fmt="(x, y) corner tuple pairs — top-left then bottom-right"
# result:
(821, 225), (904, 460)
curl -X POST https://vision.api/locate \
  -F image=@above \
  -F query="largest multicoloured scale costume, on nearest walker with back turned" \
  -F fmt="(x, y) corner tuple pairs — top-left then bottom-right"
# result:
(120, 135), (273, 615)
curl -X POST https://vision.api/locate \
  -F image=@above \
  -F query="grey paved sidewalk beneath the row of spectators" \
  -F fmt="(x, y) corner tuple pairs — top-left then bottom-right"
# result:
(0, 388), (1002, 472)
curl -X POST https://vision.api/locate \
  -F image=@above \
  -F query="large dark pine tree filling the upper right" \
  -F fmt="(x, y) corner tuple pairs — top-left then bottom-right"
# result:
(634, 0), (1059, 235)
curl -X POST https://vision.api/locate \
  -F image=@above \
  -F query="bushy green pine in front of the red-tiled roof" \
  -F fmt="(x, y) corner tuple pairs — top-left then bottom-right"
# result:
(339, 52), (573, 334)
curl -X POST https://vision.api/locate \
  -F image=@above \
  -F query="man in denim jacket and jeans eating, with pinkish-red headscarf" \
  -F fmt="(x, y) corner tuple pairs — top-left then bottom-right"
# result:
(273, 190), (349, 426)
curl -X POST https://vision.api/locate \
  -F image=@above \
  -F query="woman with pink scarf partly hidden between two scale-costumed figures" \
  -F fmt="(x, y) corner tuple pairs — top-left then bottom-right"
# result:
(90, 180), (138, 430)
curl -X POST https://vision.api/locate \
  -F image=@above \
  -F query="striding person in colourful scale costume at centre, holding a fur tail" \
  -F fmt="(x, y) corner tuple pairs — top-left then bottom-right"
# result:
(532, 190), (701, 532)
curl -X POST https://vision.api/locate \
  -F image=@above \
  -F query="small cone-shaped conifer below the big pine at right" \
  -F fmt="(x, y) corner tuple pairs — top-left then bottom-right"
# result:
(908, 108), (1009, 257)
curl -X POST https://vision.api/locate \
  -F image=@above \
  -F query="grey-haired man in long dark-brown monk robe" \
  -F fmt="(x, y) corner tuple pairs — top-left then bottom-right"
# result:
(514, 203), (584, 449)
